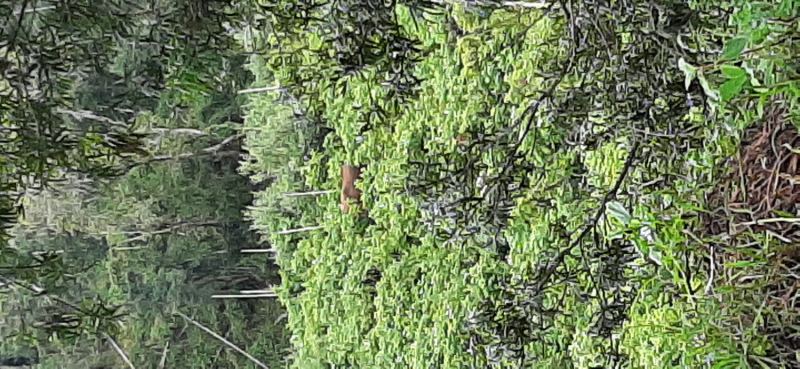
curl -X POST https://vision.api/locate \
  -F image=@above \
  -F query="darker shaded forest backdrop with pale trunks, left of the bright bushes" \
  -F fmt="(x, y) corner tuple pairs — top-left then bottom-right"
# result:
(0, 1), (288, 368)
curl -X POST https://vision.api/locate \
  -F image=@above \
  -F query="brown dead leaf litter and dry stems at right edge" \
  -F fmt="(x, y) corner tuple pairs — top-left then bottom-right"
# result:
(702, 105), (800, 367)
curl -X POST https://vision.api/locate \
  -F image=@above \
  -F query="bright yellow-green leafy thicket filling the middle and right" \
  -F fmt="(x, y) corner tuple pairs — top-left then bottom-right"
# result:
(246, 1), (798, 368)
